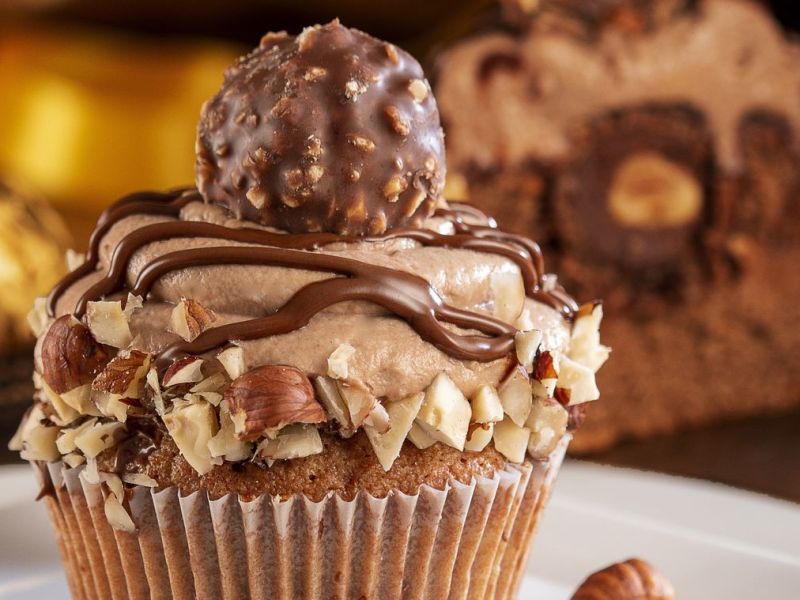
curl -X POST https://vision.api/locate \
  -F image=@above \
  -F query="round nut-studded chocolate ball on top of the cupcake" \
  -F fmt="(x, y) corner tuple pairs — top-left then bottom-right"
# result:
(196, 21), (445, 235)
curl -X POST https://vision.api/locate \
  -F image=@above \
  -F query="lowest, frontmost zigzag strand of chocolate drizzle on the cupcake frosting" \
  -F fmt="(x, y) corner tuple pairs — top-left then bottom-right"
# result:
(152, 247), (516, 361)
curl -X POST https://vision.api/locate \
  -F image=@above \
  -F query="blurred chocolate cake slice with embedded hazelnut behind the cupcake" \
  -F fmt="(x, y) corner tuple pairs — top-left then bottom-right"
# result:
(436, 0), (800, 451)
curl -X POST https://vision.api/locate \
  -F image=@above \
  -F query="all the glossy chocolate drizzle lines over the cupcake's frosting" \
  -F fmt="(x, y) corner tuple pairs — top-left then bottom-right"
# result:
(48, 190), (577, 368)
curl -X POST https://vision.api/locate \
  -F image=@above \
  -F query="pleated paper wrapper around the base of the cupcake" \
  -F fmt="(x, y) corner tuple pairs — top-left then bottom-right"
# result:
(34, 438), (569, 600)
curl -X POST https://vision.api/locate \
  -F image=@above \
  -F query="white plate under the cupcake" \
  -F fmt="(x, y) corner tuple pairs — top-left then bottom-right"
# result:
(0, 461), (800, 600)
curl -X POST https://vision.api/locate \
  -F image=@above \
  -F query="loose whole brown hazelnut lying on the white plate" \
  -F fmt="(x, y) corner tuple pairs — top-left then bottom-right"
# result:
(572, 558), (675, 600)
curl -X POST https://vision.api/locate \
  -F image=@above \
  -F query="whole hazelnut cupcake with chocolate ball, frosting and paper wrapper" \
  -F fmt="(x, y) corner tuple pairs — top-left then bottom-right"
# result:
(12, 22), (608, 598)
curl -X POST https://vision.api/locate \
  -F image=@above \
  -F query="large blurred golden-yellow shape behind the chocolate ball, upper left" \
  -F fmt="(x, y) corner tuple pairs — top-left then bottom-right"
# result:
(0, 27), (238, 219)
